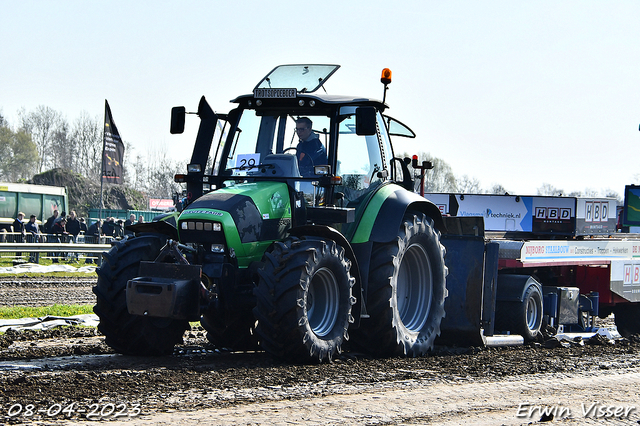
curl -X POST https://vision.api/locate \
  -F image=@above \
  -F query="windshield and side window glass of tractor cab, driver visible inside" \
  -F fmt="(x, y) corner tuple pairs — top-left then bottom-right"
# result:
(224, 106), (393, 205)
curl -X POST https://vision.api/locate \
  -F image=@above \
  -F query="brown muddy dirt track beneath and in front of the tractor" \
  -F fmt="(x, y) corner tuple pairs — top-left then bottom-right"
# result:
(0, 280), (640, 425)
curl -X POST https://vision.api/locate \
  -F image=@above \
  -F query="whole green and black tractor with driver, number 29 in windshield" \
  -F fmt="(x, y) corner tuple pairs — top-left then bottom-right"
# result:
(94, 65), (447, 362)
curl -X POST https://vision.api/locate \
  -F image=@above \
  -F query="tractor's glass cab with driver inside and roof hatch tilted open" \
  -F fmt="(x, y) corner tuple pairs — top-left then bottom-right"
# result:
(178, 65), (413, 223)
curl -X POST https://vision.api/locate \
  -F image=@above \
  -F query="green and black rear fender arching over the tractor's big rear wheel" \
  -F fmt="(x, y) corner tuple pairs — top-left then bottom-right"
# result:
(351, 184), (446, 244)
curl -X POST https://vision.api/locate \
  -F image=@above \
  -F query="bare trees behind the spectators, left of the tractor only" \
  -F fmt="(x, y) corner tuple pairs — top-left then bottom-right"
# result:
(0, 105), (184, 198)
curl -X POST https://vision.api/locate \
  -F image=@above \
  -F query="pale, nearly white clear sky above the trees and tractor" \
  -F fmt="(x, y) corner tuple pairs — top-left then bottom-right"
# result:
(0, 0), (640, 195)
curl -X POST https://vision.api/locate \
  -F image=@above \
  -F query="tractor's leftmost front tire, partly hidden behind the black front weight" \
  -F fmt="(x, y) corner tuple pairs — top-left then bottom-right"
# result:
(93, 234), (189, 355)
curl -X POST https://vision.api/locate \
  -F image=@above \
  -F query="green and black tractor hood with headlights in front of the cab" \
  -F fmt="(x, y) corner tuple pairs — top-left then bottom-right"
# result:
(178, 182), (291, 244)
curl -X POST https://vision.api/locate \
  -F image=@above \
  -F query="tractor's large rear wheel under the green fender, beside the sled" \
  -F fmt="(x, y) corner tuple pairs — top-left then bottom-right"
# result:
(351, 212), (447, 357)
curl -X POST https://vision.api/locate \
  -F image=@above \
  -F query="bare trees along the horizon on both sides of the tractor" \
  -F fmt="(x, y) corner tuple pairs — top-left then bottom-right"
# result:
(0, 105), (621, 205)
